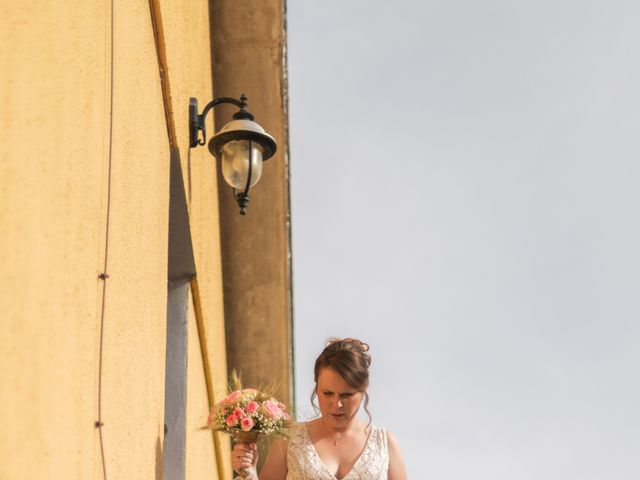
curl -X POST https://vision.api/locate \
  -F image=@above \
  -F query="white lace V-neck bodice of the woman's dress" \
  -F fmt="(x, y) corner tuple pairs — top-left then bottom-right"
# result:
(287, 424), (389, 480)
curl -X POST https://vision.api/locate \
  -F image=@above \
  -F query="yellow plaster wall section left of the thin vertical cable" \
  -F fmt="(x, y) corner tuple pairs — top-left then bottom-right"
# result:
(0, 1), (110, 479)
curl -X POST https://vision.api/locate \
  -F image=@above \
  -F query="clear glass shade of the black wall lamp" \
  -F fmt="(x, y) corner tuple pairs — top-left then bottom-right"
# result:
(222, 140), (262, 190)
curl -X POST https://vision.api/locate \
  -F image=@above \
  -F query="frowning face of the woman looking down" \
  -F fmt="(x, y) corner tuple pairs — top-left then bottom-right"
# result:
(316, 367), (366, 428)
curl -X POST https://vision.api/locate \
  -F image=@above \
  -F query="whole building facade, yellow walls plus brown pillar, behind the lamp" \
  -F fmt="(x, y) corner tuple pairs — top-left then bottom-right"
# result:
(0, 0), (293, 480)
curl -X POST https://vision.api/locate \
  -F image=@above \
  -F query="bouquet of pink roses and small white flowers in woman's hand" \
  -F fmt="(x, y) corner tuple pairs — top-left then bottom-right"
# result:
(207, 388), (291, 442)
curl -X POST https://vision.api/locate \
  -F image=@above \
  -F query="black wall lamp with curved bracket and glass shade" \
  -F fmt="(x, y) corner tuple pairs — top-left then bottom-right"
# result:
(189, 94), (277, 215)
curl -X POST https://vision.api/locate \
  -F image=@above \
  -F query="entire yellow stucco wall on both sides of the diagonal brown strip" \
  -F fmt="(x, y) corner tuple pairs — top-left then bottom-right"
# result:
(0, 0), (228, 480)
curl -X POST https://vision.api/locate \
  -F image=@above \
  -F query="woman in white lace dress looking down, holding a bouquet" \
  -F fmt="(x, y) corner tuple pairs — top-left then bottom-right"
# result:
(231, 338), (407, 480)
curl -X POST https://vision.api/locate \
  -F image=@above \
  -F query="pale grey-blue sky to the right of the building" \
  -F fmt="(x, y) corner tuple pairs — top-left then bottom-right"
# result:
(287, 0), (640, 480)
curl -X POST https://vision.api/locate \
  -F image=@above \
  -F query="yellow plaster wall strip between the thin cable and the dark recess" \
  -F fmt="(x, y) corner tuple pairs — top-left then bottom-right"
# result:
(97, 2), (169, 478)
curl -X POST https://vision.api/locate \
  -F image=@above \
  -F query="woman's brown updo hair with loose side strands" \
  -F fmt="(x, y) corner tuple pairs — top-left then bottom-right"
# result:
(311, 338), (371, 424)
